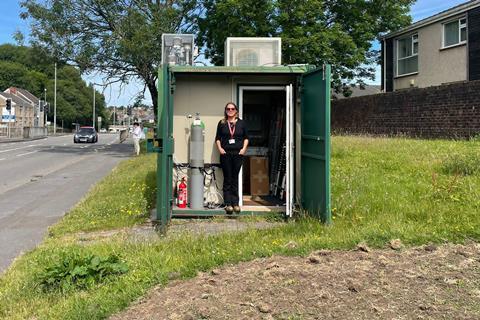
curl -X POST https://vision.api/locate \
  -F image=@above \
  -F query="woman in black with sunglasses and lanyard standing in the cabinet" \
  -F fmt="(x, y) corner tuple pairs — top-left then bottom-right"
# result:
(215, 102), (248, 214)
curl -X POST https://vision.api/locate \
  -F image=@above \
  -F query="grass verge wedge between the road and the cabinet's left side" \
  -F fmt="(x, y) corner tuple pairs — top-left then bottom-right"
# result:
(50, 154), (157, 237)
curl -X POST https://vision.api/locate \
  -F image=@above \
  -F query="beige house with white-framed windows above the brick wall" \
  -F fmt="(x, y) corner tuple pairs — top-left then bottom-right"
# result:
(381, 0), (480, 92)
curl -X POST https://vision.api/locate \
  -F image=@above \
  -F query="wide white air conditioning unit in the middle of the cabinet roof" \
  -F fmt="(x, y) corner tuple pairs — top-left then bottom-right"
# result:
(225, 37), (282, 67)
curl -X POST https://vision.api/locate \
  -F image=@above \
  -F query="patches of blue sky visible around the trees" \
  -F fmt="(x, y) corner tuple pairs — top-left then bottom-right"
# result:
(0, 0), (467, 106)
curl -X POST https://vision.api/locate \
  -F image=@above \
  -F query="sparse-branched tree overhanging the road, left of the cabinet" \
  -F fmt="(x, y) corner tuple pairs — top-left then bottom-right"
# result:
(21, 0), (197, 118)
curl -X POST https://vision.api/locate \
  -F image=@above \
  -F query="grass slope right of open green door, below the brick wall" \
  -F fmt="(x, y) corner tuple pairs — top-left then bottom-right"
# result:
(332, 137), (480, 243)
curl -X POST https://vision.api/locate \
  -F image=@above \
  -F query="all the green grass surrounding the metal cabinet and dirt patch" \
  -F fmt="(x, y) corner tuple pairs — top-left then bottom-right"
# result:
(0, 137), (480, 319)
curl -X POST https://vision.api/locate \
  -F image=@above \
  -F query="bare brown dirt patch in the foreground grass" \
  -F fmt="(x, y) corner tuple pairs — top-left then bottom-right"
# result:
(111, 243), (480, 320)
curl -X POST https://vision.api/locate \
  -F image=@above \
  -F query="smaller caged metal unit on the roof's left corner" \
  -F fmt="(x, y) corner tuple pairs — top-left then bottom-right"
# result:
(162, 33), (195, 66)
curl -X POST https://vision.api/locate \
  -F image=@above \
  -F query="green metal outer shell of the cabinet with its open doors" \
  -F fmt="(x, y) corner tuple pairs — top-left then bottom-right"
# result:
(154, 65), (331, 226)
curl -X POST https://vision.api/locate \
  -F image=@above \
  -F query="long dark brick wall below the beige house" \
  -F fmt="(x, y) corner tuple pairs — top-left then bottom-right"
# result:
(331, 80), (480, 138)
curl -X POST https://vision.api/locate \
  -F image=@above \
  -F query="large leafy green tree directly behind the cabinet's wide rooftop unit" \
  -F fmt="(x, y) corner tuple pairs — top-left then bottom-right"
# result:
(198, 0), (415, 91)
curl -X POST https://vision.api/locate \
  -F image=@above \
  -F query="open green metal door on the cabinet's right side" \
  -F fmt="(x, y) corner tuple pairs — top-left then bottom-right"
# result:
(301, 65), (331, 223)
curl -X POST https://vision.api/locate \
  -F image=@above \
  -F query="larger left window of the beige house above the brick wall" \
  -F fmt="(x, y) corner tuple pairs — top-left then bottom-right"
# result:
(397, 34), (418, 76)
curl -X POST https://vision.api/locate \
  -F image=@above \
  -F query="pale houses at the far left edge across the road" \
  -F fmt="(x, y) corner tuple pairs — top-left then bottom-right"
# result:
(0, 87), (45, 128)
